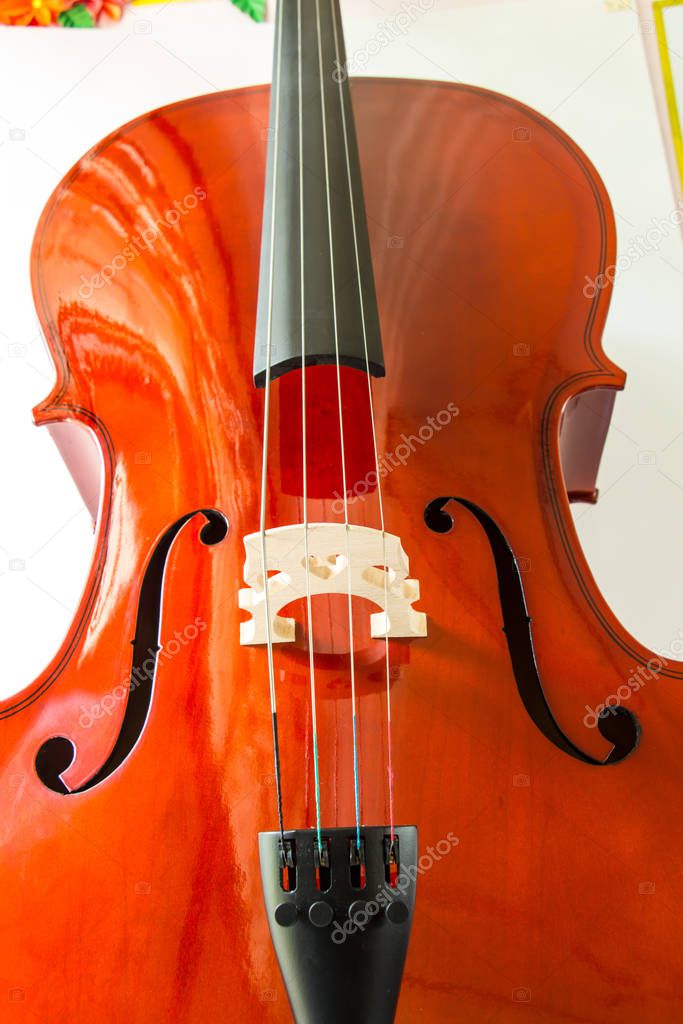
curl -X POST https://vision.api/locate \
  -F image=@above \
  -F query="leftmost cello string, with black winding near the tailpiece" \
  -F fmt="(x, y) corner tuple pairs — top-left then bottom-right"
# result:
(259, 0), (285, 847)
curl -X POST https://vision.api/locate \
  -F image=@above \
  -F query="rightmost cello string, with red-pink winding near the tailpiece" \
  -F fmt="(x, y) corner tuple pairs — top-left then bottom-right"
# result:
(331, 0), (395, 843)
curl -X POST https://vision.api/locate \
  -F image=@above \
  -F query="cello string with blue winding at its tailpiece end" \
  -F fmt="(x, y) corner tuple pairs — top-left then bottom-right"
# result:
(315, 0), (360, 850)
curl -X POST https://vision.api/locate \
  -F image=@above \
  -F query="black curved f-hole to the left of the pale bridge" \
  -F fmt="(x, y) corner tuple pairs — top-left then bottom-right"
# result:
(36, 509), (227, 796)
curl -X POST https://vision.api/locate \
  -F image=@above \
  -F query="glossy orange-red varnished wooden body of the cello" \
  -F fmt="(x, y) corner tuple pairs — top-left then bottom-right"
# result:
(5, 80), (683, 1024)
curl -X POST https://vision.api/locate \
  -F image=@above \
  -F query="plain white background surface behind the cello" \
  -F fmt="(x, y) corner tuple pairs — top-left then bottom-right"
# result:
(0, 0), (683, 695)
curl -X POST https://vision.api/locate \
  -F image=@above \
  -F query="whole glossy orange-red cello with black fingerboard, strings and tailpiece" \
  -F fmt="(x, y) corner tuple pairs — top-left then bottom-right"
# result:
(6, 0), (683, 1024)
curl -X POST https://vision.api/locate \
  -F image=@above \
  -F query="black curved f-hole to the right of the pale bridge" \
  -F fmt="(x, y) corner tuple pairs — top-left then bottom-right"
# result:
(424, 498), (641, 765)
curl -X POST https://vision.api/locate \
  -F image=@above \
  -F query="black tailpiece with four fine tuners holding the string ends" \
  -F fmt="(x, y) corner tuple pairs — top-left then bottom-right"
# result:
(258, 825), (418, 1024)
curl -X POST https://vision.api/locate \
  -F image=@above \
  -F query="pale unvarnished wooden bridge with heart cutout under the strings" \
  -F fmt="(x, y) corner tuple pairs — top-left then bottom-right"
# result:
(239, 522), (427, 644)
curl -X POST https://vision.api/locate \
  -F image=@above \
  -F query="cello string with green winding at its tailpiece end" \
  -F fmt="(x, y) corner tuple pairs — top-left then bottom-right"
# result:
(296, 0), (323, 851)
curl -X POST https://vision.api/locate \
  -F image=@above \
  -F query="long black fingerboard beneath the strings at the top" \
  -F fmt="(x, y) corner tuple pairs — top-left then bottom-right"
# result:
(254, 0), (384, 386)
